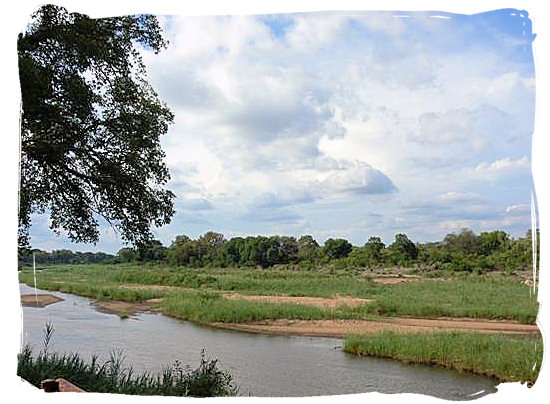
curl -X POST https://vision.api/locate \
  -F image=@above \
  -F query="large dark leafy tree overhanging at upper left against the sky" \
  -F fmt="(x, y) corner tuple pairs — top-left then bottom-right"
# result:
(17, 5), (174, 246)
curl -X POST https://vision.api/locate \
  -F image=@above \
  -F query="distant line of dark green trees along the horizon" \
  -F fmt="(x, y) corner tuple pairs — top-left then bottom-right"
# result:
(20, 229), (539, 272)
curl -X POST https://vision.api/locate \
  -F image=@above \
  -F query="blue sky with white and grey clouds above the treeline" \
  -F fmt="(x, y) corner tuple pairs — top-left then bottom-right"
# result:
(27, 10), (535, 252)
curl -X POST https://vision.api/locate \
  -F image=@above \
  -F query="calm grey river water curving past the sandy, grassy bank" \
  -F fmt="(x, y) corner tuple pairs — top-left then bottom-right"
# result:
(20, 284), (497, 400)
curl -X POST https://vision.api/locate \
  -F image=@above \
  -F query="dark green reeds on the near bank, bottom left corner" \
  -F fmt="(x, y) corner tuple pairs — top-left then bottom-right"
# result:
(17, 324), (237, 397)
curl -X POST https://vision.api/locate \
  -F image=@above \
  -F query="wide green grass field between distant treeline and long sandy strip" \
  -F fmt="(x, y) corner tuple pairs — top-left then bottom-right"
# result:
(19, 264), (538, 324)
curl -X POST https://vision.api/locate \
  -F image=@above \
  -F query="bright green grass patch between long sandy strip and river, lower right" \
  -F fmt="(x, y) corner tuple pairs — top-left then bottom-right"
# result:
(344, 332), (543, 386)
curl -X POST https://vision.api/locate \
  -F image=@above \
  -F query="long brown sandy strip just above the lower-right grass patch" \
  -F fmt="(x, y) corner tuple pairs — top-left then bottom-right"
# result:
(212, 317), (540, 338)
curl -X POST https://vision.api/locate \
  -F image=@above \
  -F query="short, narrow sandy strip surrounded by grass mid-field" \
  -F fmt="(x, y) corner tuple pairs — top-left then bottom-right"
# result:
(223, 293), (372, 309)
